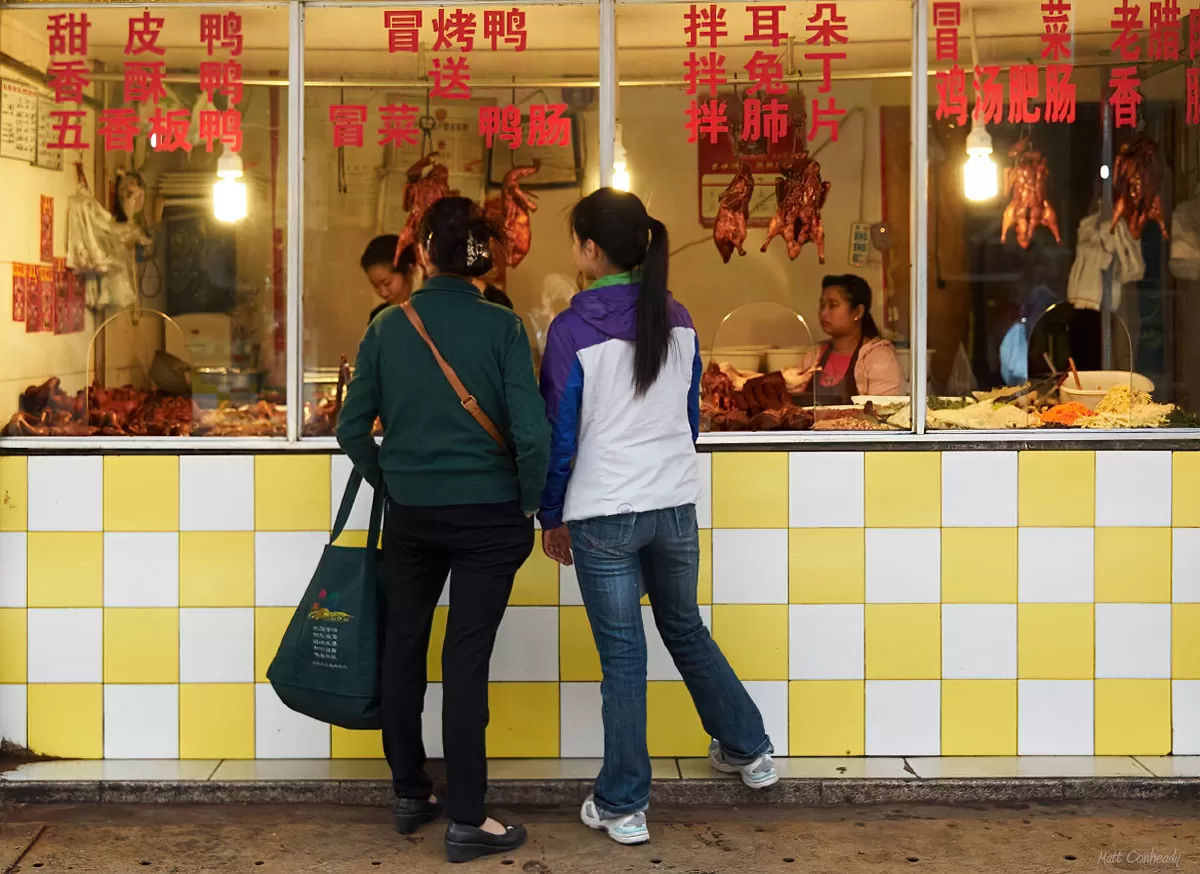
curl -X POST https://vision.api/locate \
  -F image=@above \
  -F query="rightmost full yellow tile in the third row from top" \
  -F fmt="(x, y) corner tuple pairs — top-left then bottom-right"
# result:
(1016, 604), (1096, 680)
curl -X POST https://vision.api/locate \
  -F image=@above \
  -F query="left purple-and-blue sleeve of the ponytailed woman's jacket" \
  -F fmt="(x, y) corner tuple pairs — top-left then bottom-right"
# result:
(538, 319), (583, 529)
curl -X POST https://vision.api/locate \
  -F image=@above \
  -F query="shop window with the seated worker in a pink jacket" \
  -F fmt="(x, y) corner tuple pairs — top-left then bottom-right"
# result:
(614, 0), (912, 431)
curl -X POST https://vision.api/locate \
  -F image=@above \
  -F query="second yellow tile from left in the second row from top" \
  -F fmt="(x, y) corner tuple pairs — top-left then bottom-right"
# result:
(179, 531), (254, 607)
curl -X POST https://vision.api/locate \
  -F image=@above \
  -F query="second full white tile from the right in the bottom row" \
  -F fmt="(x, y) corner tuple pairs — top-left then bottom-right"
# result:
(866, 680), (942, 755)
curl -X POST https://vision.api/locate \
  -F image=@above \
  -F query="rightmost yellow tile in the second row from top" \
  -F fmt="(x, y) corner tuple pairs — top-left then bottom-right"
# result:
(1096, 528), (1171, 604)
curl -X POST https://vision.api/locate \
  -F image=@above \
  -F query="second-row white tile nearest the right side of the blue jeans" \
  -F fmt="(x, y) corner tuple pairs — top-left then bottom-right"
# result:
(713, 528), (787, 604)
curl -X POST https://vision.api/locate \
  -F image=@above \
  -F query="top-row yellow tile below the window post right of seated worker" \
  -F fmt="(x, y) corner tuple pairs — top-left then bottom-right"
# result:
(865, 451), (942, 528)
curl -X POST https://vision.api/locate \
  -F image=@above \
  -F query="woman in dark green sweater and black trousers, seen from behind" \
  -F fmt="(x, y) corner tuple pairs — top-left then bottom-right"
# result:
(337, 197), (550, 862)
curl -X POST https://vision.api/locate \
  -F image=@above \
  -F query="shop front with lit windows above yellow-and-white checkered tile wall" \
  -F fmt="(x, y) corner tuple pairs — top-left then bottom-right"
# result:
(0, 0), (1200, 759)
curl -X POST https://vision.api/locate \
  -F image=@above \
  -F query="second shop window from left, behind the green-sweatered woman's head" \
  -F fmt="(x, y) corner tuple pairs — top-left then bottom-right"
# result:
(302, 2), (600, 436)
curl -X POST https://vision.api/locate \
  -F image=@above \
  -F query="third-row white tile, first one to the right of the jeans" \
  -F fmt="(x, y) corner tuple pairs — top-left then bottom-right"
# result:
(787, 604), (865, 680)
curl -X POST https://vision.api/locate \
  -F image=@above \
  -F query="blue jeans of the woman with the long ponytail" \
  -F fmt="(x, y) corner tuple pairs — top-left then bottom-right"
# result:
(569, 504), (772, 815)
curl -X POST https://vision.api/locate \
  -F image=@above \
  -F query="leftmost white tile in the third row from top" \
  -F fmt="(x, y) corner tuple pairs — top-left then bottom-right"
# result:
(28, 607), (104, 683)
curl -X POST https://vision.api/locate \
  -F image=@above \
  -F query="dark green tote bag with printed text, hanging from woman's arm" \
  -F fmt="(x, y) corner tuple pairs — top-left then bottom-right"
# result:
(266, 471), (384, 729)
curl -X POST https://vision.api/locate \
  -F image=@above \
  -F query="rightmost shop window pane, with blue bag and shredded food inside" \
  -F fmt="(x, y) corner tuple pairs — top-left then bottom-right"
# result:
(928, 0), (1200, 430)
